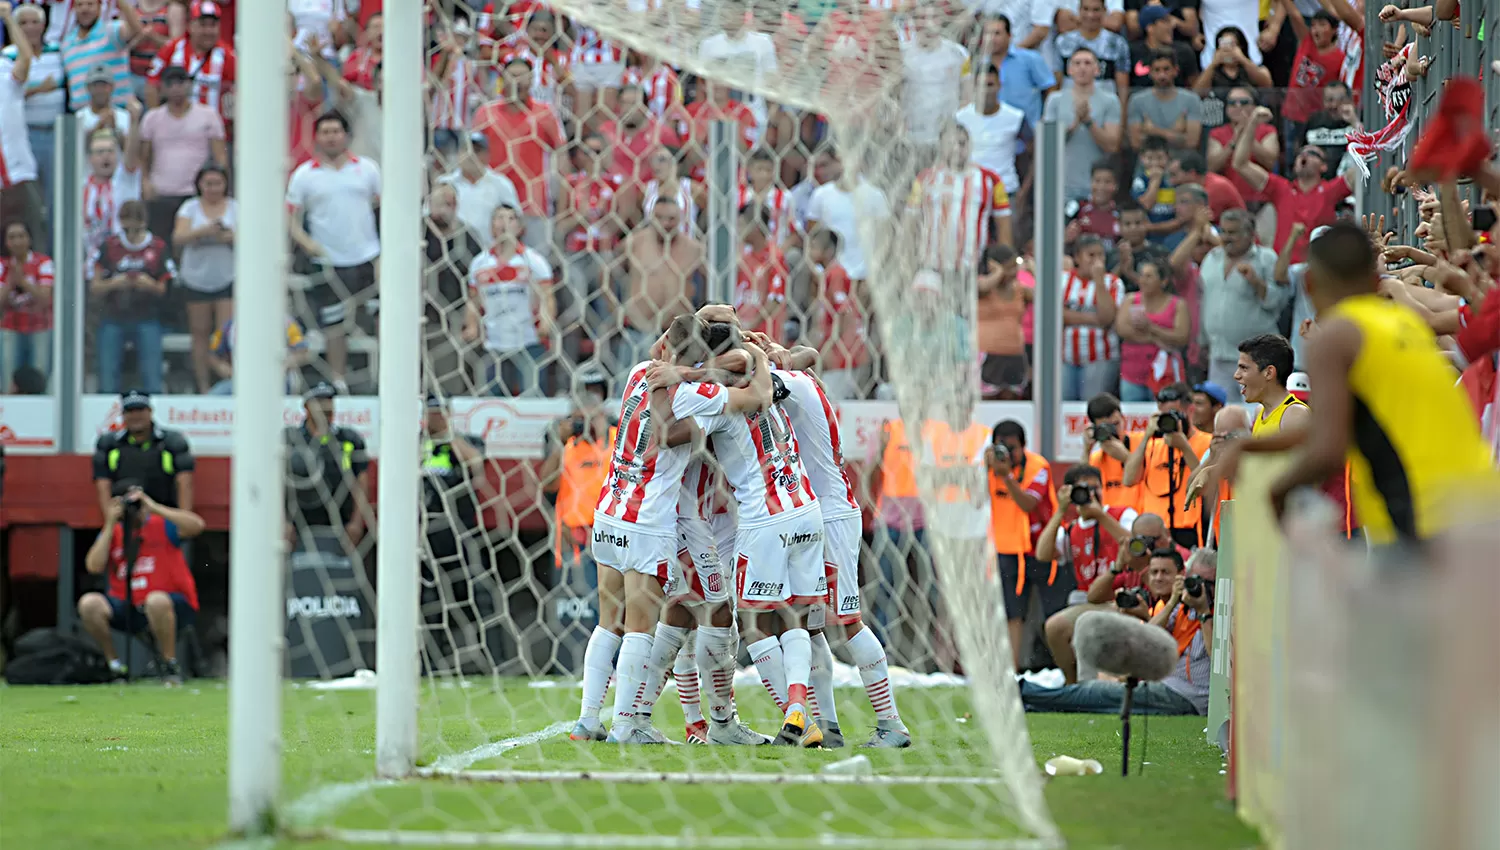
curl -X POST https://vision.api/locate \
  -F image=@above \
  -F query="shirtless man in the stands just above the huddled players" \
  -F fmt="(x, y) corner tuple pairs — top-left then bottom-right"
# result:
(615, 198), (704, 370)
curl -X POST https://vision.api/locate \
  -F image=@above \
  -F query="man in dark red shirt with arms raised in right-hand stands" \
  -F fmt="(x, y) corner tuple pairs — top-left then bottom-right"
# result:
(1232, 106), (1358, 262)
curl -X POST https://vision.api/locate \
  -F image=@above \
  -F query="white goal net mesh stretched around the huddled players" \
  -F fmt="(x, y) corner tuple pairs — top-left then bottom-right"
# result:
(287, 0), (1059, 847)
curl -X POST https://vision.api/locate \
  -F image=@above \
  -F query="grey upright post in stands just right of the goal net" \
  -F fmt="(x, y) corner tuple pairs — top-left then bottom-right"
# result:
(1032, 120), (1067, 462)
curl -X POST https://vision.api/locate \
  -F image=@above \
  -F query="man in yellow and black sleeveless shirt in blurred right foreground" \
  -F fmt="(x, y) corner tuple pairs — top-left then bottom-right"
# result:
(1271, 222), (1500, 546)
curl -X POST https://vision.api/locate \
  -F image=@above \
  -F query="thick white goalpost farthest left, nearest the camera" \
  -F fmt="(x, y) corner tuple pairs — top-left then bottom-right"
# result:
(230, 3), (290, 834)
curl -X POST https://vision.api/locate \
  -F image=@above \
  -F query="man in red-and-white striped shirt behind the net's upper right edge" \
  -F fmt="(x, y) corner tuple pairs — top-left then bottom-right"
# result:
(911, 123), (1011, 288)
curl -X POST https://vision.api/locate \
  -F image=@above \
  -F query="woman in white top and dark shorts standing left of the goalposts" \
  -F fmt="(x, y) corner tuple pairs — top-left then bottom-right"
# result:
(173, 162), (239, 393)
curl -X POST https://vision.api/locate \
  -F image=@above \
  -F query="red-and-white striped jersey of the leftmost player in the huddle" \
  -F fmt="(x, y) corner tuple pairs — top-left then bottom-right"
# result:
(594, 363), (726, 534)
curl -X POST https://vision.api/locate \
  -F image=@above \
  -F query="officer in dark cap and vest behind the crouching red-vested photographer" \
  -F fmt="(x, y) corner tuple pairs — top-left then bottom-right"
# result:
(93, 390), (195, 516)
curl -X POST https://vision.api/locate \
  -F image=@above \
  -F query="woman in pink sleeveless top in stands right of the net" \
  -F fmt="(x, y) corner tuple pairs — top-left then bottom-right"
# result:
(1115, 262), (1191, 402)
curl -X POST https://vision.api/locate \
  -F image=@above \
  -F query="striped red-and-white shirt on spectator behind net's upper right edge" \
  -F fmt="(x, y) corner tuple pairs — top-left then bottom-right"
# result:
(909, 165), (1011, 271)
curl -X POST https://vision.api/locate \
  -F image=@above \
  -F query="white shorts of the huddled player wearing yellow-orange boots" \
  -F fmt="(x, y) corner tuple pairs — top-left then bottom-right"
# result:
(735, 504), (828, 610)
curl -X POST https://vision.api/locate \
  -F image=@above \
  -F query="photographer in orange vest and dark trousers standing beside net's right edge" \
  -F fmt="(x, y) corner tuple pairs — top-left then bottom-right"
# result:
(984, 420), (1073, 669)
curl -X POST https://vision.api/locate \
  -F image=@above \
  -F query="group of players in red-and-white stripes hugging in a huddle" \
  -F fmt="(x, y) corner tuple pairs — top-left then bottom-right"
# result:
(570, 304), (912, 748)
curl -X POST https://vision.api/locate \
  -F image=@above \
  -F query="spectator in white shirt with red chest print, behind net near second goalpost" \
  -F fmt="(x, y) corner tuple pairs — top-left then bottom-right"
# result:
(464, 207), (558, 396)
